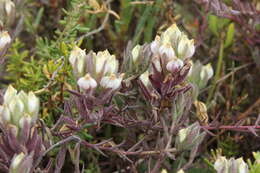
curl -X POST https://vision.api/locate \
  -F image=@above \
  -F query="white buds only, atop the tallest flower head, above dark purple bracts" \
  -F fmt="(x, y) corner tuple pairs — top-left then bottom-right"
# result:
(151, 24), (195, 73)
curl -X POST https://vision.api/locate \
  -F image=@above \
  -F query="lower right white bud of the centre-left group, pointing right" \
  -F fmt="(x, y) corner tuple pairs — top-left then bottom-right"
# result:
(100, 74), (124, 90)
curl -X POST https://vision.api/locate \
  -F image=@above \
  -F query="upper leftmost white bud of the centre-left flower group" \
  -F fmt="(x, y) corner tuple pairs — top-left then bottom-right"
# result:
(69, 46), (87, 75)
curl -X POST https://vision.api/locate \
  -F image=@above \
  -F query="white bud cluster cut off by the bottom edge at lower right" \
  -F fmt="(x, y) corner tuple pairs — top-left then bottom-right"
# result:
(214, 156), (249, 173)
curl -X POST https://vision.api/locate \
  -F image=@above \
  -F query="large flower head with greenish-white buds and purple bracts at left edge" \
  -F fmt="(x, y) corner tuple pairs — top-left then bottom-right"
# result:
(0, 86), (49, 173)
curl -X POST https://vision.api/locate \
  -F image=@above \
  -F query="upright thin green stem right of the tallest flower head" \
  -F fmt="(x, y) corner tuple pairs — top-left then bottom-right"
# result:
(207, 41), (224, 105)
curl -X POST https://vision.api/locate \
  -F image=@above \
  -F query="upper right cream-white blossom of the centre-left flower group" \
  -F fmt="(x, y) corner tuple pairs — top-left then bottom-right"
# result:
(93, 50), (118, 75)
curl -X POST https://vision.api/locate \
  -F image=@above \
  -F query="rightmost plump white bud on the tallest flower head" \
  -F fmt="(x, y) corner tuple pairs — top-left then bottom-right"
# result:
(177, 34), (195, 59)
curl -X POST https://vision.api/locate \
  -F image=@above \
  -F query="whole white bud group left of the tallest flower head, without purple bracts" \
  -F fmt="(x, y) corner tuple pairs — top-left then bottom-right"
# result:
(69, 46), (124, 91)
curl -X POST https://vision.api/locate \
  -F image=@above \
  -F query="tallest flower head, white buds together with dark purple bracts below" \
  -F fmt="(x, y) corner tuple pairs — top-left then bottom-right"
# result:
(132, 24), (195, 102)
